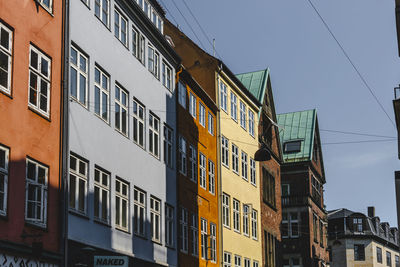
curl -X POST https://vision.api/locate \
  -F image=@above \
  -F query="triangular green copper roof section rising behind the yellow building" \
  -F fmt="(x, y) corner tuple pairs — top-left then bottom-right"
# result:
(236, 69), (269, 103)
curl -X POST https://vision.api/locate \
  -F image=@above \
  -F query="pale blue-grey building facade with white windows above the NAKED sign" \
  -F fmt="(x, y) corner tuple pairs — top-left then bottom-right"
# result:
(67, 0), (179, 266)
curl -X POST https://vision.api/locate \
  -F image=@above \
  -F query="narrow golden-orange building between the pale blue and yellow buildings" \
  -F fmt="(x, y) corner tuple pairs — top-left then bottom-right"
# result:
(177, 69), (219, 266)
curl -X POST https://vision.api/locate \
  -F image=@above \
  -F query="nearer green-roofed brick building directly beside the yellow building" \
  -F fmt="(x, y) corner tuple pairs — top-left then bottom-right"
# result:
(237, 69), (282, 267)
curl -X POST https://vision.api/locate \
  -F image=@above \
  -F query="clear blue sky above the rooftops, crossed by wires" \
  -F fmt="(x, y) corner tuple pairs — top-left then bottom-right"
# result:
(160, 0), (400, 226)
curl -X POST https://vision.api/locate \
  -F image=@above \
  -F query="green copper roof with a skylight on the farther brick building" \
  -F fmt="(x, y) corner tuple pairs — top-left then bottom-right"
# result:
(277, 109), (317, 163)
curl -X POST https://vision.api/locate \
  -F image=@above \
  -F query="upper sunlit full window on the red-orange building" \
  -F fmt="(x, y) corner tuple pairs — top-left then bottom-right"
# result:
(28, 45), (51, 117)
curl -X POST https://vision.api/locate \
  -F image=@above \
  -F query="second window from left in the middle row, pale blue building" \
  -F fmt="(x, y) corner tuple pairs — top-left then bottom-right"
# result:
(94, 67), (110, 122)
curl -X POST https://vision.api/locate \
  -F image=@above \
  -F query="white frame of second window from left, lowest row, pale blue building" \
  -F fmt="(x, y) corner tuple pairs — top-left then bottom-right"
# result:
(93, 169), (111, 224)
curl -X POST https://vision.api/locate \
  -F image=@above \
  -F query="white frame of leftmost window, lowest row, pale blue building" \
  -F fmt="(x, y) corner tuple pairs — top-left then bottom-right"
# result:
(68, 155), (89, 214)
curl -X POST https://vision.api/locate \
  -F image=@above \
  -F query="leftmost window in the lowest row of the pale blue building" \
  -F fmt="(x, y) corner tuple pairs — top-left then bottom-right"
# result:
(69, 155), (88, 214)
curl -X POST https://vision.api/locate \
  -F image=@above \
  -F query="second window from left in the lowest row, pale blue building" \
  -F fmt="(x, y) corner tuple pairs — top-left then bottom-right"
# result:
(94, 167), (110, 223)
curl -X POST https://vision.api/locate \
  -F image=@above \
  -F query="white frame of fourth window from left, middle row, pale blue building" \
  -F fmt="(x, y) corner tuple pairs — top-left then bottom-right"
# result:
(132, 99), (146, 149)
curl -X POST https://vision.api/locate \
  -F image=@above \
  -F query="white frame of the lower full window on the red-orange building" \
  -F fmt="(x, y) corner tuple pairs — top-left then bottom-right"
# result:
(25, 158), (49, 227)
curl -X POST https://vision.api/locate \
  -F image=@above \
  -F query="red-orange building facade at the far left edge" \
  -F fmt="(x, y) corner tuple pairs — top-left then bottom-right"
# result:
(0, 0), (63, 266)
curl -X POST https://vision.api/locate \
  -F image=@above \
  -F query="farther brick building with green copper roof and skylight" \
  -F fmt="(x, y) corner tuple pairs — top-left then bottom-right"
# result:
(278, 110), (329, 267)
